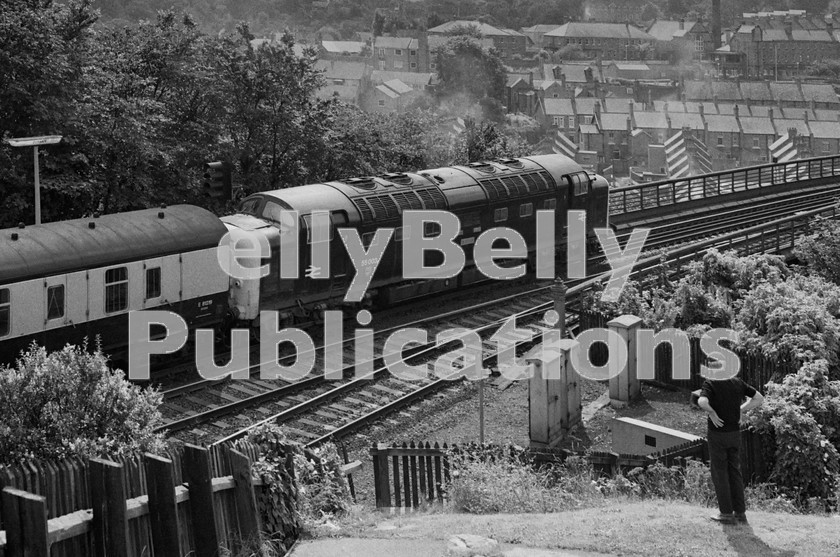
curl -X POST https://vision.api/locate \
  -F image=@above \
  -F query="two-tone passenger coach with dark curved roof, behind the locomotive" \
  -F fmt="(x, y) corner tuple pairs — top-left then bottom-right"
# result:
(0, 205), (229, 363)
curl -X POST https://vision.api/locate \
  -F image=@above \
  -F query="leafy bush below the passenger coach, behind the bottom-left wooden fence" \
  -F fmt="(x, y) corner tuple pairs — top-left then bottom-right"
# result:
(0, 344), (164, 464)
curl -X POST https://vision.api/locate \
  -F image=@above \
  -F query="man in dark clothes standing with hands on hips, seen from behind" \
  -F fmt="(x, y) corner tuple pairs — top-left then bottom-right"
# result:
(697, 377), (764, 524)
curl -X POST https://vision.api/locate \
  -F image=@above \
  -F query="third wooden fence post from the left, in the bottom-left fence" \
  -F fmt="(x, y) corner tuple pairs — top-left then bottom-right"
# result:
(143, 453), (182, 557)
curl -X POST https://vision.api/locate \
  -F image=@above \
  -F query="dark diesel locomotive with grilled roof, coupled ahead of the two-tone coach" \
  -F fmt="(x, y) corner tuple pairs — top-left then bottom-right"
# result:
(223, 155), (607, 322)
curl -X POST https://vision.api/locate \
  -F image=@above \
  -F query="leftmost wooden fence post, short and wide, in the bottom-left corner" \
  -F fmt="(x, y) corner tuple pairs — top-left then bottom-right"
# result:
(2, 487), (50, 557)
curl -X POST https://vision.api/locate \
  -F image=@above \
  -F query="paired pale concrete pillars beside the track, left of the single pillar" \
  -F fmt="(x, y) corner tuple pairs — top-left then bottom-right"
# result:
(525, 339), (581, 447)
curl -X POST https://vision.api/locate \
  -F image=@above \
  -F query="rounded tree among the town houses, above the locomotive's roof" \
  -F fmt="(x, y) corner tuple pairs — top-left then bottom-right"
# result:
(435, 36), (507, 103)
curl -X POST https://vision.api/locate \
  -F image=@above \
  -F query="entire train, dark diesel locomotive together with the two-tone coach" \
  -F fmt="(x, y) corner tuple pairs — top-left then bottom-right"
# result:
(0, 155), (609, 363)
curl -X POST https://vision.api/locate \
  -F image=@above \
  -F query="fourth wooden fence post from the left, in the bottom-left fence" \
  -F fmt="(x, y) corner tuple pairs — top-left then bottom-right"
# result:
(181, 444), (219, 557)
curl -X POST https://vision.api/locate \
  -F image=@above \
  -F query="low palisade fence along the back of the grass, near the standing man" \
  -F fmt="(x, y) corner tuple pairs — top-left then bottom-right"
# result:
(370, 429), (769, 509)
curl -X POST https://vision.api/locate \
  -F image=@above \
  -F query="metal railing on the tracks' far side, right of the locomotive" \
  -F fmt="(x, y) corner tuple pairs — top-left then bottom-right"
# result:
(610, 155), (840, 220)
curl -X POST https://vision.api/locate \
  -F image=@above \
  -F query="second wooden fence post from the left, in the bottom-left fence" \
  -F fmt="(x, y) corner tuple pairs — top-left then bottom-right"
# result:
(89, 458), (128, 557)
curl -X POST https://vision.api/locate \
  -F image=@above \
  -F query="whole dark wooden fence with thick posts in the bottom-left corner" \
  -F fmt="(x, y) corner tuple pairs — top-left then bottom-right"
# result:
(0, 441), (298, 557)
